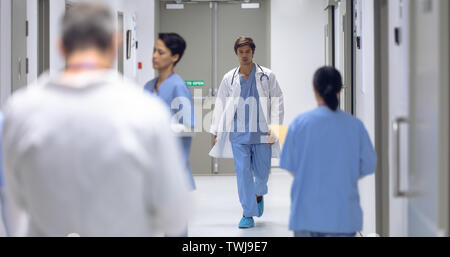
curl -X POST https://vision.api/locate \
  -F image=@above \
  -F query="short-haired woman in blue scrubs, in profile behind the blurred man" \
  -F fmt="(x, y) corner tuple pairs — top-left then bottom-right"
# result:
(145, 33), (195, 190)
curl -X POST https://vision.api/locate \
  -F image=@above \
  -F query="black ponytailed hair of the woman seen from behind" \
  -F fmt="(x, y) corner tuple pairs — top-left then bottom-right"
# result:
(313, 67), (342, 111)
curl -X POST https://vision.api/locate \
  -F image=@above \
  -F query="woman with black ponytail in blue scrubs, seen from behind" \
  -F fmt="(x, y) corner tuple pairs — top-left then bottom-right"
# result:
(280, 67), (377, 237)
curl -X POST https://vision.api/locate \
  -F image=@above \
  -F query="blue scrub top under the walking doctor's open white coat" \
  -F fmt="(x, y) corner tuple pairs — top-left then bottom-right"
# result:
(230, 65), (267, 145)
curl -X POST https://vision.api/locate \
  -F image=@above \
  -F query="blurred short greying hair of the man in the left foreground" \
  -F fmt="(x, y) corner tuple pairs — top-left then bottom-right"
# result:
(62, 3), (115, 54)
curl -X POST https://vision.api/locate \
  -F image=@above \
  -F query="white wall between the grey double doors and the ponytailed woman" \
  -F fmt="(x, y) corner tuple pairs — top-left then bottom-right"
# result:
(271, 0), (327, 125)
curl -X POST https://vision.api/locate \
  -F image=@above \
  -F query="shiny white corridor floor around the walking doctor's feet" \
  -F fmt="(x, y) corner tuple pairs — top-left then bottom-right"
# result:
(189, 169), (293, 237)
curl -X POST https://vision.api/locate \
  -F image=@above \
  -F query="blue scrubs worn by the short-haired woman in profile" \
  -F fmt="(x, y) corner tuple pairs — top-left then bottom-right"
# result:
(144, 74), (195, 189)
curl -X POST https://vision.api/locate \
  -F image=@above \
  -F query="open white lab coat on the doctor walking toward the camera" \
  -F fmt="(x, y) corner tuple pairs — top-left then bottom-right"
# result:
(209, 64), (284, 159)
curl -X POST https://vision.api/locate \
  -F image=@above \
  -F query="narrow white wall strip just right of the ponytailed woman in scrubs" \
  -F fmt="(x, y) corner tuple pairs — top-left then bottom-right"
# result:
(356, 0), (376, 235)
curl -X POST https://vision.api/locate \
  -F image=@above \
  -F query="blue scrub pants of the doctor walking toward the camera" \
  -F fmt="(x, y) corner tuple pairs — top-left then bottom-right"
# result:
(232, 144), (272, 217)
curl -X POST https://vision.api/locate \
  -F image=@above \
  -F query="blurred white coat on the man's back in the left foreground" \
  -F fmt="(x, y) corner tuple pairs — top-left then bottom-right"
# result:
(3, 71), (191, 237)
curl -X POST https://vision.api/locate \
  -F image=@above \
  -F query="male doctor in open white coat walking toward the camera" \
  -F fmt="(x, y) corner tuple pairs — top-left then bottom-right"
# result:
(210, 37), (284, 229)
